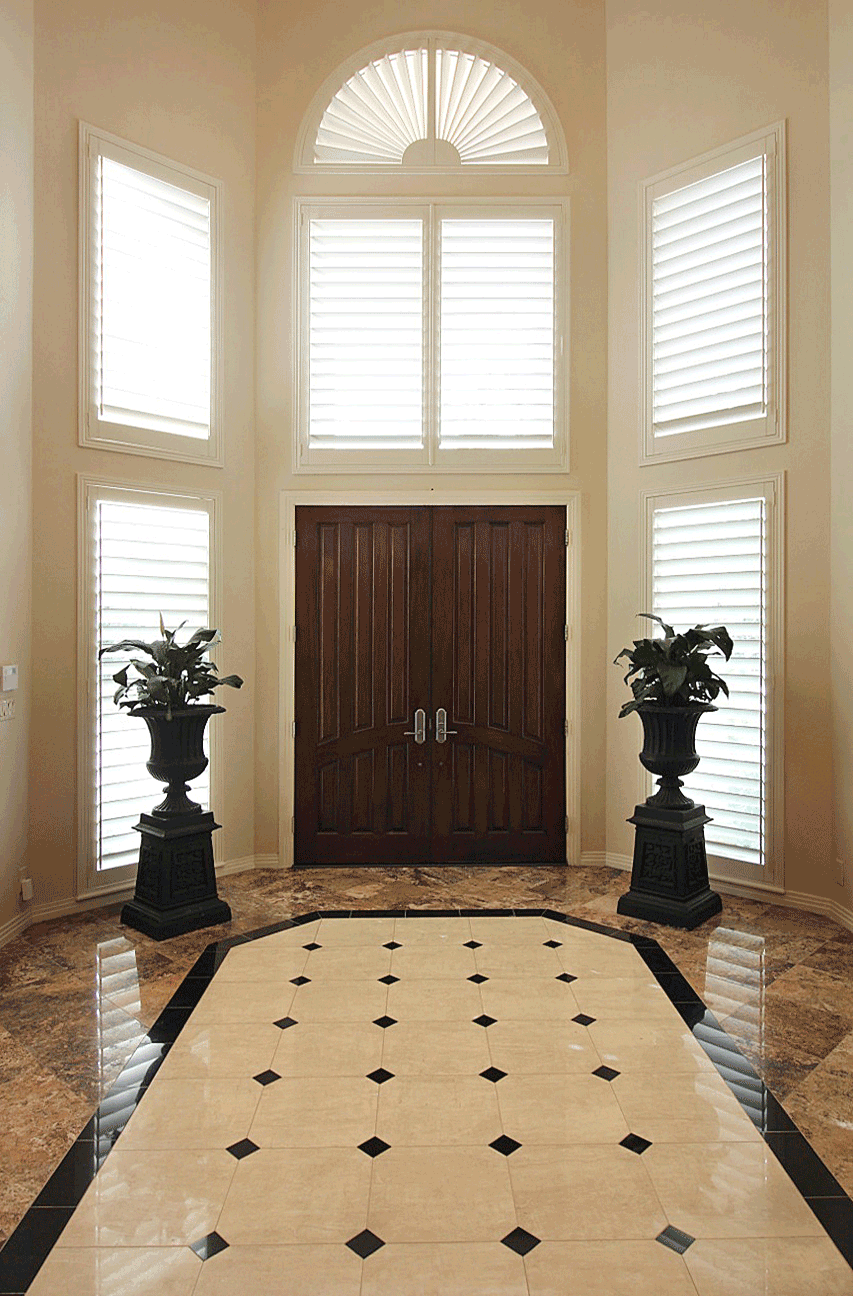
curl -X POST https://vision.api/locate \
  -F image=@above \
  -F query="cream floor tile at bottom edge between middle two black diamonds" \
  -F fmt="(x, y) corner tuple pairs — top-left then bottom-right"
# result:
(362, 1242), (528, 1296)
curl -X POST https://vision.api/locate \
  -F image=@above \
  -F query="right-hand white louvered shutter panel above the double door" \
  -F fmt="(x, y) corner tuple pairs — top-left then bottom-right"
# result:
(439, 218), (555, 448)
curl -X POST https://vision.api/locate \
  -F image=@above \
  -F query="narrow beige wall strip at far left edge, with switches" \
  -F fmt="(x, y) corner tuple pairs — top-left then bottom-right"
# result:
(0, 0), (32, 931)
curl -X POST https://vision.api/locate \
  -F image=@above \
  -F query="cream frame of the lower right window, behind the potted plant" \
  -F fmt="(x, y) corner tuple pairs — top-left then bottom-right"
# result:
(638, 472), (786, 893)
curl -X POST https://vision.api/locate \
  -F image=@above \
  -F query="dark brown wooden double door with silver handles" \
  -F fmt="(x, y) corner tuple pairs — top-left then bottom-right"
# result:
(294, 505), (565, 864)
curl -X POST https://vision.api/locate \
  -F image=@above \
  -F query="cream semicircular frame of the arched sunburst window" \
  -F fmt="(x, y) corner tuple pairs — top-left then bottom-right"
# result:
(293, 30), (568, 176)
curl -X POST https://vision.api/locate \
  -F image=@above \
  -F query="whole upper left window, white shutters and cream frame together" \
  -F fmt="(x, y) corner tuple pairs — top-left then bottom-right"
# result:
(79, 123), (222, 463)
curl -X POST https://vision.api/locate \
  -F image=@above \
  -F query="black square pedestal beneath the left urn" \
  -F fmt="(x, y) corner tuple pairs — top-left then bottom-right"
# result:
(122, 811), (231, 941)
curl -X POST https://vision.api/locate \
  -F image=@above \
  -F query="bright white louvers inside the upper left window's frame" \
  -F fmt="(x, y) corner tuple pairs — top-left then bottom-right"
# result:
(95, 156), (211, 439)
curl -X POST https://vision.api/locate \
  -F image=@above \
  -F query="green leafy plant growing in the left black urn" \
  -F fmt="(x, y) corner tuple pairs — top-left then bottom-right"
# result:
(97, 613), (242, 719)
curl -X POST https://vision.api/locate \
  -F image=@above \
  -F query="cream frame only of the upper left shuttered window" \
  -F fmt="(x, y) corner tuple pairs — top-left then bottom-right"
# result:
(78, 122), (224, 468)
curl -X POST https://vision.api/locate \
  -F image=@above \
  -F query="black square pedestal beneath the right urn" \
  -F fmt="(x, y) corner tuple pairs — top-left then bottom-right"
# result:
(616, 802), (722, 931)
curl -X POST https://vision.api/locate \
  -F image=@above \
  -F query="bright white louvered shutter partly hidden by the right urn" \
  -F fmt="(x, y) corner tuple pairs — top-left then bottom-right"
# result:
(652, 499), (767, 864)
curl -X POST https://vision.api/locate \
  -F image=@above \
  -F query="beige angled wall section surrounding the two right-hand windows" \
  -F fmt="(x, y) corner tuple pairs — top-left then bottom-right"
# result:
(607, 0), (829, 898)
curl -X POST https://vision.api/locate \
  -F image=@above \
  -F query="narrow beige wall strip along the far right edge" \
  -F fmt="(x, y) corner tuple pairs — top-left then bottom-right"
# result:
(830, 0), (853, 910)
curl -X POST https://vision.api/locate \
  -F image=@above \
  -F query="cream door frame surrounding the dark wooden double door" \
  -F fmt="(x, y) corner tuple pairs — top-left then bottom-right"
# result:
(279, 486), (581, 868)
